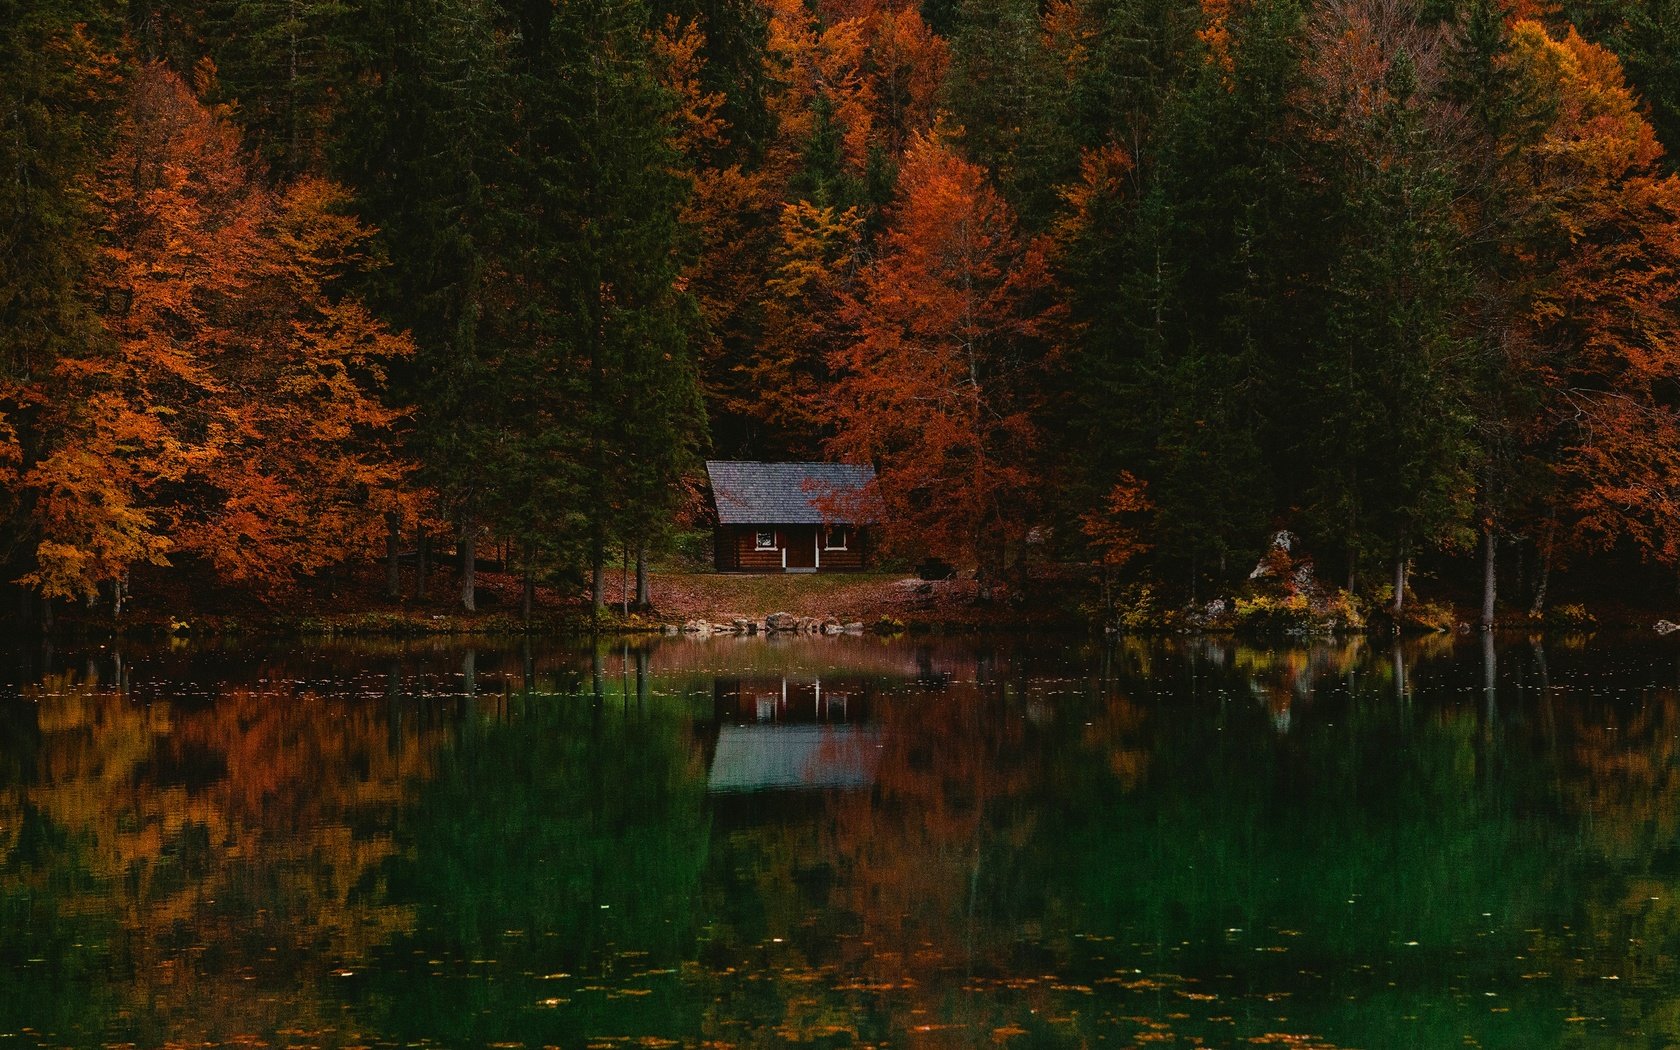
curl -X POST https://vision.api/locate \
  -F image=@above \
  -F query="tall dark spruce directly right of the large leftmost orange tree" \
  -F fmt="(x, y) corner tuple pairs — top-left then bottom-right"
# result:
(334, 0), (509, 610)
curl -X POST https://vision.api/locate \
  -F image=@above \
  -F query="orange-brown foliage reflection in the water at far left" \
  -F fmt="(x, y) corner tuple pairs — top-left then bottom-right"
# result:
(0, 675), (440, 1037)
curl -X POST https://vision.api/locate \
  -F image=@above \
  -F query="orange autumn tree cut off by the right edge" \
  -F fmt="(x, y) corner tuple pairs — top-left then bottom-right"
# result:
(1510, 22), (1680, 564)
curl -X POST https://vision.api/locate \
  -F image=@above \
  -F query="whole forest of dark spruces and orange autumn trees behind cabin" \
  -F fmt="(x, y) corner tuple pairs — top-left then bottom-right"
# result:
(0, 0), (1680, 622)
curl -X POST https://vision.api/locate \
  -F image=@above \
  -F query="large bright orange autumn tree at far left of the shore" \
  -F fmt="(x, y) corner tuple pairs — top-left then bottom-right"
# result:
(24, 66), (408, 601)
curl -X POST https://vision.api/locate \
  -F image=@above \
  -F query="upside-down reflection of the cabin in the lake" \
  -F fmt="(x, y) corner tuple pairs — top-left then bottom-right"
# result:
(706, 677), (880, 795)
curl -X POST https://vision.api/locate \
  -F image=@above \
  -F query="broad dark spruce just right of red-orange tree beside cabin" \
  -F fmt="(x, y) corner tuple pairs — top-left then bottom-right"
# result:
(1063, 0), (1314, 595)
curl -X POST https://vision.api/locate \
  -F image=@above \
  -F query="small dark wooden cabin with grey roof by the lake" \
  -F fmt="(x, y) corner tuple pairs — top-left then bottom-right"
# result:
(706, 460), (875, 573)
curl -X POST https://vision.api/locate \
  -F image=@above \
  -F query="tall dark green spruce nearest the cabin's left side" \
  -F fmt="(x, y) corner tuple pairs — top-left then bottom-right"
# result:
(514, 0), (704, 606)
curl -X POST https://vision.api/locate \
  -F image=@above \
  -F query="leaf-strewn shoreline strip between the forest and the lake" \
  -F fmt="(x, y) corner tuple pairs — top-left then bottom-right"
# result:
(15, 566), (1680, 642)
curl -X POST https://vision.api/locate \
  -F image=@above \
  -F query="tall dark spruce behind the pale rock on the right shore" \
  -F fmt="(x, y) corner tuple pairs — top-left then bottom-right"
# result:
(1302, 22), (1475, 613)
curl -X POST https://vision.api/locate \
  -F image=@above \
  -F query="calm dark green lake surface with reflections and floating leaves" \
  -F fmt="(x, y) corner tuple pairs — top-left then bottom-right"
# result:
(0, 637), (1680, 1050)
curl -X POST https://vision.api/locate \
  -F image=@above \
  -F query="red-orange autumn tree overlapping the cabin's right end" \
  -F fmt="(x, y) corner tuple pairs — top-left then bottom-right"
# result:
(822, 134), (1055, 598)
